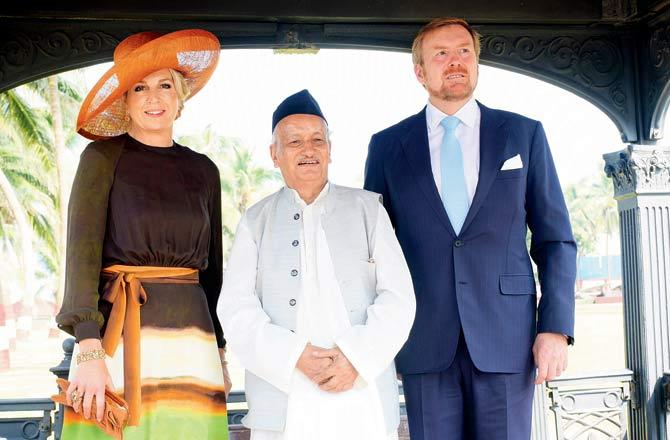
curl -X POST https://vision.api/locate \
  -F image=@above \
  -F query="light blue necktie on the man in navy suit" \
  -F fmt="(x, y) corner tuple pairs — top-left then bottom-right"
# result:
(440, 116), (470, 235)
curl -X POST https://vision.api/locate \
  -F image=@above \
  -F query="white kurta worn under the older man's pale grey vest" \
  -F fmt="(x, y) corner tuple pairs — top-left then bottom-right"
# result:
(218, 184), (415, 440)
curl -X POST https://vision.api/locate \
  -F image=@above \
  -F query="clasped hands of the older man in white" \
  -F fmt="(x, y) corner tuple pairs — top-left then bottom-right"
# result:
(296, 343), (358, 393)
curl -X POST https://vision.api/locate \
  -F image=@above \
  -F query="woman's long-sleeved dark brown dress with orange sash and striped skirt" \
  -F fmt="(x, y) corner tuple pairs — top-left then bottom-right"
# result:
(57, 134), (228, 440)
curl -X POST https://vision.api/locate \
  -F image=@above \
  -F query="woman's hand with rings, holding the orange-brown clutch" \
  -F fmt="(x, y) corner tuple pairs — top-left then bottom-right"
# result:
(66, 339), (114, 421)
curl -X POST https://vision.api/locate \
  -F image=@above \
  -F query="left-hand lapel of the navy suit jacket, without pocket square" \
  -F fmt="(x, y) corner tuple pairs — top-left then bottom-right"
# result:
(401, 107), (456, 235)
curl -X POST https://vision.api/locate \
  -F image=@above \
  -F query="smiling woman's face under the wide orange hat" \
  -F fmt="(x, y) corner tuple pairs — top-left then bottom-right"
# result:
(126, 69), (179, 135)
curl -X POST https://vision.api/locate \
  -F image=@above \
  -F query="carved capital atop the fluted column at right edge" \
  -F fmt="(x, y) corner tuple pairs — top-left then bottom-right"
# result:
(603, 145), (670, 199)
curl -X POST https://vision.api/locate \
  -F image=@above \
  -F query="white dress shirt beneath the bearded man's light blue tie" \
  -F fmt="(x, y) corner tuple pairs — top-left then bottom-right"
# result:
(426, 97), (481, 204)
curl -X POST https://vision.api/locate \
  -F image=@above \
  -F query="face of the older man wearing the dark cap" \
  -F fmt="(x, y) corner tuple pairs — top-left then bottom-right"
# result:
(270, 114), (330, 192)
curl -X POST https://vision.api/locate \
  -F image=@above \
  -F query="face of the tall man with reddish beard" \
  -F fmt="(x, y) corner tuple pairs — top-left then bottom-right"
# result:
(414, 25), (479, 102)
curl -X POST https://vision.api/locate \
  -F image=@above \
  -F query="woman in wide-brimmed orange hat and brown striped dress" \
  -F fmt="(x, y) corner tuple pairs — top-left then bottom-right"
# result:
(56, 30), (230, 440)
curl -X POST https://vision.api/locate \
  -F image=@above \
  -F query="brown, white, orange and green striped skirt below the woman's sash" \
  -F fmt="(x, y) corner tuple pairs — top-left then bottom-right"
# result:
(61, 281), (228, 440)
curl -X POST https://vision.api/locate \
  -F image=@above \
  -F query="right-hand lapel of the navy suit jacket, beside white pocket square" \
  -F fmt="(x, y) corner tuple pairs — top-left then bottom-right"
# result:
(461, 103), (509, 231)
